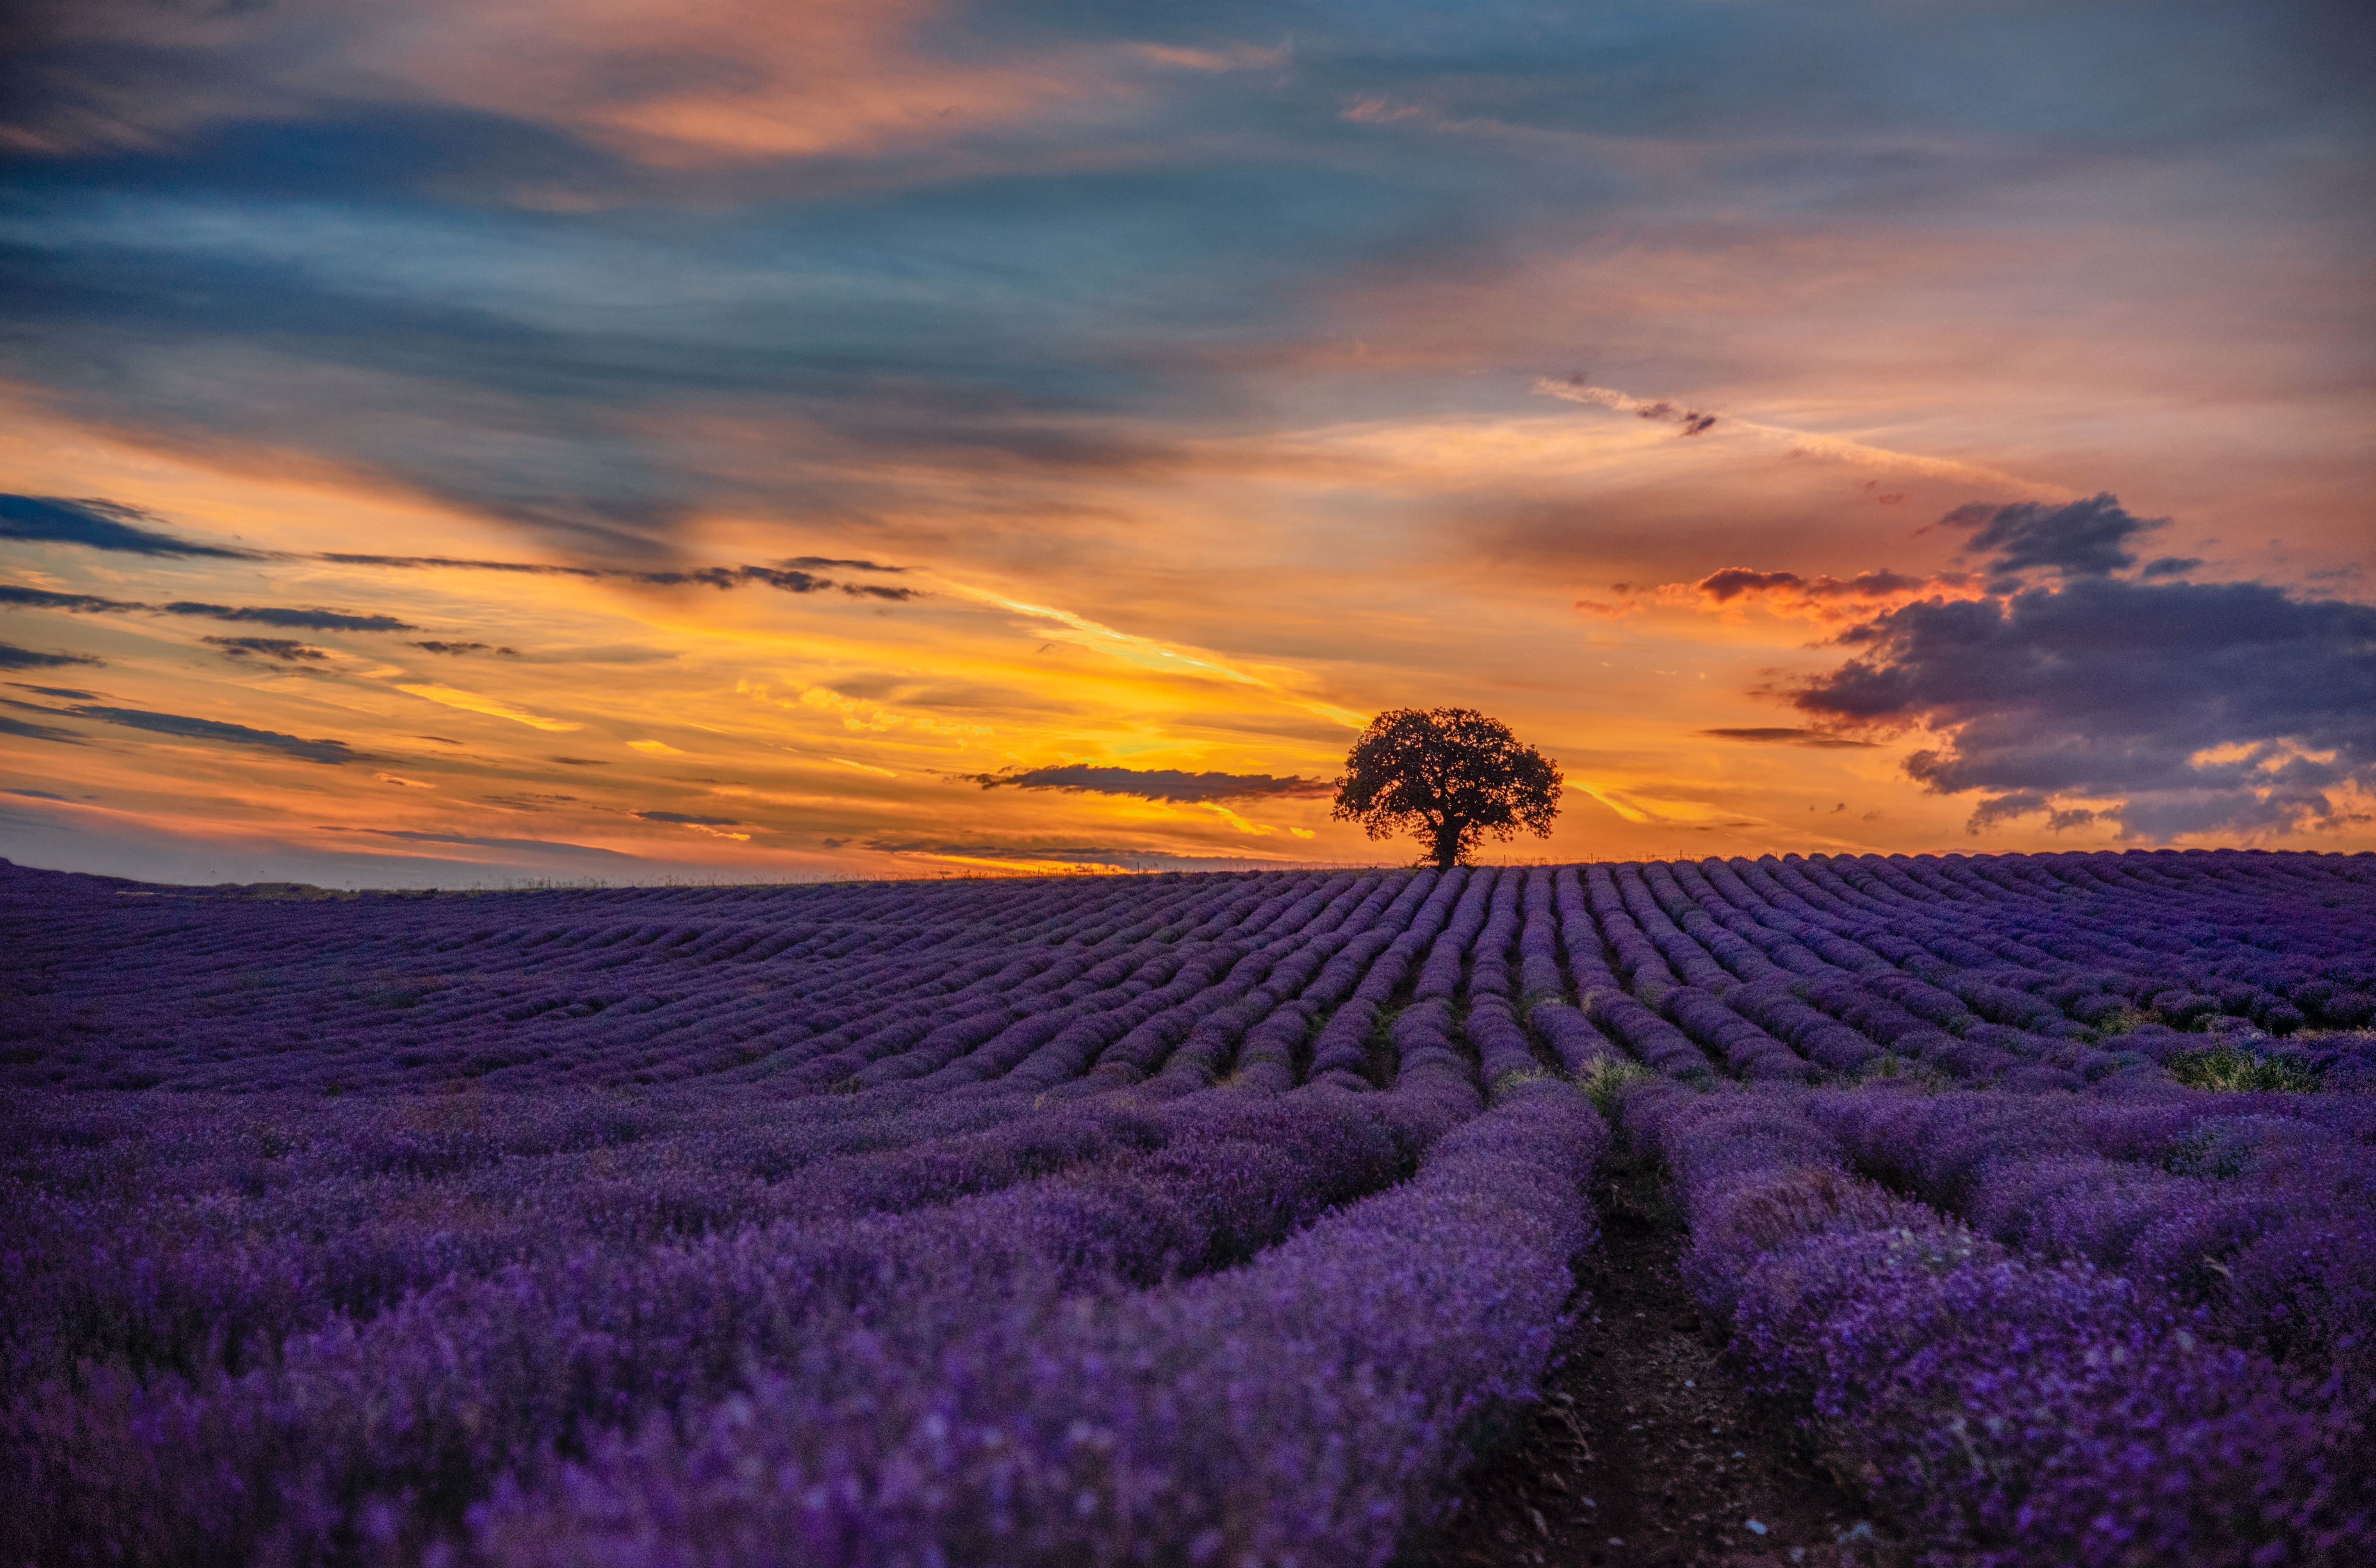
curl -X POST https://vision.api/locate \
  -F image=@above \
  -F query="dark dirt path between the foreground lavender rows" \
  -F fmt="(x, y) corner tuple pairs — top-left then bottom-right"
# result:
(1414, 1155), (1903, 1568)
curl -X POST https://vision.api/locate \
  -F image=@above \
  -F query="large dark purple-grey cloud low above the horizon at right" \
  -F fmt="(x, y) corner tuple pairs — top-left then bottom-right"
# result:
(1791, 575), (2376, 839)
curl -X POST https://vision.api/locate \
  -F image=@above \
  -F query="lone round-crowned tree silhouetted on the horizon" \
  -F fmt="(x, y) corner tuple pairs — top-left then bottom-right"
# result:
(1331, 708), (1559, 870)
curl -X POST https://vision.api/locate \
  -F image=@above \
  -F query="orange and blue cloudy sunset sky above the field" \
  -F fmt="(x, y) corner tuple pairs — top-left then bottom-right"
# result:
(0, 0), (2376, 886)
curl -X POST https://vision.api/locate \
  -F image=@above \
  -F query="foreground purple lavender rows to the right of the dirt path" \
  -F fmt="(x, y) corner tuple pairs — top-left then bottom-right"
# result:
(1623, 1083), (2376, 1568)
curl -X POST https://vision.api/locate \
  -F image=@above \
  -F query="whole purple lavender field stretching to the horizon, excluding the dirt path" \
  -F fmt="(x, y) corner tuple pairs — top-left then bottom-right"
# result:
(0, 850), (2376, 1568)
